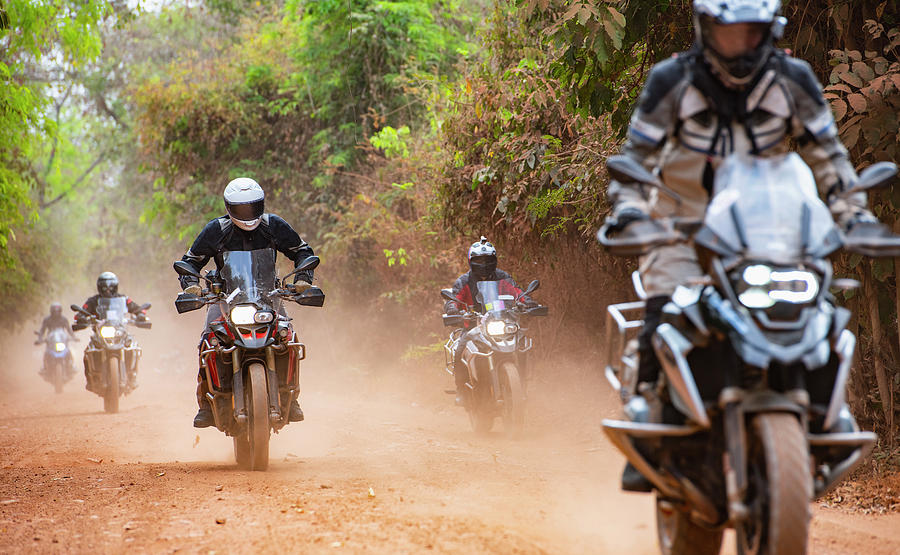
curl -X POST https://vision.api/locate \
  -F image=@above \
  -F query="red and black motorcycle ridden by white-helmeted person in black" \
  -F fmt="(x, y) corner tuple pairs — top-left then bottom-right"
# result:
(175, 249), (325, 470)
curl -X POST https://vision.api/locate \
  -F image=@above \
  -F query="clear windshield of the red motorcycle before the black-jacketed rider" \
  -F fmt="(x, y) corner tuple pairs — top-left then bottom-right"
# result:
(221, 249), (276, 307)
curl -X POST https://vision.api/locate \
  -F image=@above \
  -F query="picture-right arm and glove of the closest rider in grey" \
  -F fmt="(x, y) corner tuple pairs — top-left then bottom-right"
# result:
(782, 56), (868, 228)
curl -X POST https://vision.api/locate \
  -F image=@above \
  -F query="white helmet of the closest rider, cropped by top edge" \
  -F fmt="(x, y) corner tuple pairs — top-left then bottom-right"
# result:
(694, 0), (787, 89)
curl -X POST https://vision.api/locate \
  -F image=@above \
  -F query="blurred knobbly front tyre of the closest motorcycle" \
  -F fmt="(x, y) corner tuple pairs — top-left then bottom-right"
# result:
(735, 413), (812, 555)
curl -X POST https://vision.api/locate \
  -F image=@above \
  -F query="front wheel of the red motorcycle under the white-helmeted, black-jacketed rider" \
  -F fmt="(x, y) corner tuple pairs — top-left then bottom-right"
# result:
(234, 362), (269, 470)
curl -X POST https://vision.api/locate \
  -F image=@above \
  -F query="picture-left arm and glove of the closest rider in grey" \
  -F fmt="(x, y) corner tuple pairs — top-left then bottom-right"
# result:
(607, 58), (687, 216)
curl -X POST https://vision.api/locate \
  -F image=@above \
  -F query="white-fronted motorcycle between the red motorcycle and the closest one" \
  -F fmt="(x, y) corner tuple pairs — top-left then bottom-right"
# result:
(441, 280), (548, 436)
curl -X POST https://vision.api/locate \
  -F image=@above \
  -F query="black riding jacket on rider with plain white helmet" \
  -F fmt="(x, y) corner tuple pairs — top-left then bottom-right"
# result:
(178, 214), (315, 289)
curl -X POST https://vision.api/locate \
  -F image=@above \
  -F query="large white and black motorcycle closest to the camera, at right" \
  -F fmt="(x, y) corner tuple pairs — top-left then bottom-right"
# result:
(598, 153), (900, 554)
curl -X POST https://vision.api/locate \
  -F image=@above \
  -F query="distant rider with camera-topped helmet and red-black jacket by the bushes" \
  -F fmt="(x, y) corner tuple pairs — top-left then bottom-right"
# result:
(444, 235), (537, 406)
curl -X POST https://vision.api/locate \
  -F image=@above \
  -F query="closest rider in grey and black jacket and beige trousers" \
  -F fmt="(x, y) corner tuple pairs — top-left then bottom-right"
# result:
(609, 0), (877, 491)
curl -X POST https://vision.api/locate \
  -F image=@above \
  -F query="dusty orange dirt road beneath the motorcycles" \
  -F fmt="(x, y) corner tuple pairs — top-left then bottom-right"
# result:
(0, 310), (900, 554)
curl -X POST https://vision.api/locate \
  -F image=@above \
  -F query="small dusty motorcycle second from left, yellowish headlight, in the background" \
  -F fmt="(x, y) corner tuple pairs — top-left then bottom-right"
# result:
(70, 297), (152, 414)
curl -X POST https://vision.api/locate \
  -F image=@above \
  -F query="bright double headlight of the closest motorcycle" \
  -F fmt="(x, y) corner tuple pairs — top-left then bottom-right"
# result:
(737, 264), (819, 308)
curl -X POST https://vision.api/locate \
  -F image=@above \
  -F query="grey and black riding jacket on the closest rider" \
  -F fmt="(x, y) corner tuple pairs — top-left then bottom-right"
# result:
(609, 50), (866, 223)
